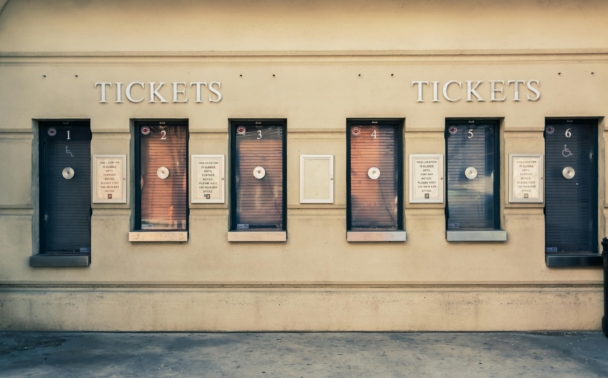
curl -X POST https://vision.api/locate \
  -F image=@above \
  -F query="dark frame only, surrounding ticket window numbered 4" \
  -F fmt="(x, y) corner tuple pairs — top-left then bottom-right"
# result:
(346, 118), (405, 232)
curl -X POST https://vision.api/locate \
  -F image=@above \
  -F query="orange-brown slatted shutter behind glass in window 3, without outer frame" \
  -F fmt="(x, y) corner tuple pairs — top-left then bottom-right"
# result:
(233, 124), (285, 230)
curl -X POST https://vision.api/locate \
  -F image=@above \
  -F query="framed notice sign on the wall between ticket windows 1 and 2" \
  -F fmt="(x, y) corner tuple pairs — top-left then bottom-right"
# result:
(93, 155), (127, 203)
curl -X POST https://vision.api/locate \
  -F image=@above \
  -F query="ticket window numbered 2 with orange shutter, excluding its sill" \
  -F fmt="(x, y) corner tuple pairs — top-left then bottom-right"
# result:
(132, 121), (188, 232)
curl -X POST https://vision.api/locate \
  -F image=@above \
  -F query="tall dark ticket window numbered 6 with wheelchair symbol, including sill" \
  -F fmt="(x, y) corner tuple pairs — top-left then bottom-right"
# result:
(544, 119), (602, 267)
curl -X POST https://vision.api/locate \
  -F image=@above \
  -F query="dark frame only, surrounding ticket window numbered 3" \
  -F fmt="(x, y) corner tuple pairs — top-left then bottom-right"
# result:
(228, 118), (287, 232)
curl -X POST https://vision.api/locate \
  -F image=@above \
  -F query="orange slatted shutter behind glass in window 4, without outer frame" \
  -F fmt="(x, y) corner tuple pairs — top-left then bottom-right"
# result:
(349, 125), (400, 230)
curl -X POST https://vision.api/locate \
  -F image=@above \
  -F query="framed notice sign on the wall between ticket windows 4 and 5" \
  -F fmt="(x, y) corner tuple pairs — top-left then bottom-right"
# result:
(410, 154), (444, 203)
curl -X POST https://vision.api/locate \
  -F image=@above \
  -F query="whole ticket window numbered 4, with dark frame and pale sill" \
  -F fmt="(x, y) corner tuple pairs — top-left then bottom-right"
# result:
(347, 120), (405, 242)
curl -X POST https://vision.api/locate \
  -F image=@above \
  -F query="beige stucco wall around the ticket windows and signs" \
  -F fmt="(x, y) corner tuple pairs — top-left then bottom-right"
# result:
(0, 0), (608, 330)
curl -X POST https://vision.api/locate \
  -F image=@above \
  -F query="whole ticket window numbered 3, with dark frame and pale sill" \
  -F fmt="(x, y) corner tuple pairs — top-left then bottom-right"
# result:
(229, 120), (286, 241)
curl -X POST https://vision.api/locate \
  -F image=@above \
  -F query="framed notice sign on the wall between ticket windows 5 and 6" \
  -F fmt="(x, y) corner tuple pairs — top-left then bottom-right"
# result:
(509, 154), (545, 203)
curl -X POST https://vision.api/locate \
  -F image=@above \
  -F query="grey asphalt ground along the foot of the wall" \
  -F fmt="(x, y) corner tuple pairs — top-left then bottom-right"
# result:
(0, 332), (608, 378)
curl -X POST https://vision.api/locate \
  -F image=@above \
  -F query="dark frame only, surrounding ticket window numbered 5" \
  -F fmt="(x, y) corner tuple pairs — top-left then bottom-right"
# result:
(444, 118), (502, 232)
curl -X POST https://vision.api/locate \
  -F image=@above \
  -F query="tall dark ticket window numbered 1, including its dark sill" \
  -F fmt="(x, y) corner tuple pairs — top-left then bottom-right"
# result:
(30, 121), (91, 267)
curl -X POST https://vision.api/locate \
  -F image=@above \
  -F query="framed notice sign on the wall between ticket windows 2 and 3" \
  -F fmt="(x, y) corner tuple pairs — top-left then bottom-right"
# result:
(190, 155), (225, 203)
